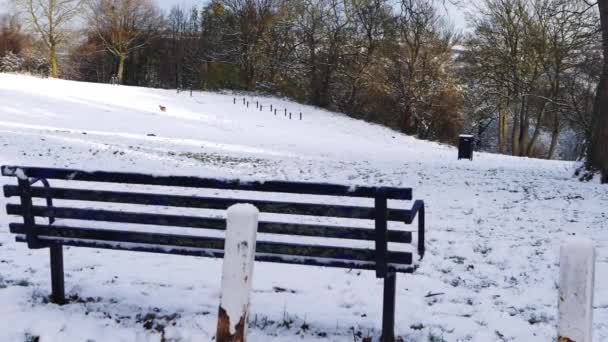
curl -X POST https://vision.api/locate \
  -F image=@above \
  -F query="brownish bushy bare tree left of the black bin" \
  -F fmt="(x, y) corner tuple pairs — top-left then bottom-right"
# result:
(386, 0), (455, 137)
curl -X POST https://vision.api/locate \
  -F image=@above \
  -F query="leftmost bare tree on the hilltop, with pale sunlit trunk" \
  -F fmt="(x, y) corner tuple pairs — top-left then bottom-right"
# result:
(13, 0), (84, 77)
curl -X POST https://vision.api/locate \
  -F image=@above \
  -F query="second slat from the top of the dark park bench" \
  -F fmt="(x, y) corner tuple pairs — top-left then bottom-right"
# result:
(4, 185), (411, 222)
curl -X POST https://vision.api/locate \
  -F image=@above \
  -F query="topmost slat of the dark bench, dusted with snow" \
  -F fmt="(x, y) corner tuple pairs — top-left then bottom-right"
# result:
(2, 166), (412, 200)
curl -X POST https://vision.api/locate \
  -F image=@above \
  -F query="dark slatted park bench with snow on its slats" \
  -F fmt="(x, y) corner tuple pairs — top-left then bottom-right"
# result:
(2, 166), (424, 341)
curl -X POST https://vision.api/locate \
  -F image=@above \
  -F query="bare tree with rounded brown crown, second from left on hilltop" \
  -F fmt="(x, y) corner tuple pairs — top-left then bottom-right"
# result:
(87, 0), (162, 83)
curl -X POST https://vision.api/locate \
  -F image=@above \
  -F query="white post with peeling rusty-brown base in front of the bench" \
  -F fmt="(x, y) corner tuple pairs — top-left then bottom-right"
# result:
(216, 204), (259, 342)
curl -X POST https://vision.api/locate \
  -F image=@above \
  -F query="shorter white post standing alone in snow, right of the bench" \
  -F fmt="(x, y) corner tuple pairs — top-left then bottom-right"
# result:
(557, 238), (595, 342)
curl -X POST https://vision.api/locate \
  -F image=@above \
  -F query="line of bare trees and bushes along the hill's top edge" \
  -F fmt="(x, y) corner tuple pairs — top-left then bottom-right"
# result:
(0, 0), (602, 168)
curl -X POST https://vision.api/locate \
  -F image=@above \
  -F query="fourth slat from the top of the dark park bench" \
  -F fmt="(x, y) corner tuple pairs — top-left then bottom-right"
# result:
(10, 223), (412, 265)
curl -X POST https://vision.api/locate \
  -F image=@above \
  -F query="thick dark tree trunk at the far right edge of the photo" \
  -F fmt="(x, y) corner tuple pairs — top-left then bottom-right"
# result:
(588, 0), (608, 183)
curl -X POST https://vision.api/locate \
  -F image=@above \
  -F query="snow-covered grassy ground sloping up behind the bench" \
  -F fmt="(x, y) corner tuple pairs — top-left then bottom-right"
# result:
(0, 74), (608, 342)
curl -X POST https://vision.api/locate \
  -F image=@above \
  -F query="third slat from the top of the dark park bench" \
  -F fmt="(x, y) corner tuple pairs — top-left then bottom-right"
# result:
(6, 204), (412, 243)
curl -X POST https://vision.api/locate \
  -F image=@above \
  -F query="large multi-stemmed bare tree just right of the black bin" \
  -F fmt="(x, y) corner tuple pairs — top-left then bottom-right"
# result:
(467, 0), (594, 158)
